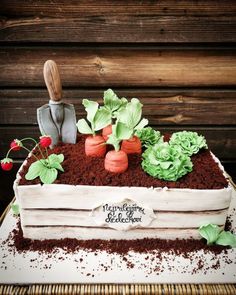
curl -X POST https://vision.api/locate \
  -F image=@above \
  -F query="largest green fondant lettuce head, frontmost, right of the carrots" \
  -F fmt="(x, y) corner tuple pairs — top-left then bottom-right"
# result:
(142, 142), (193, 181)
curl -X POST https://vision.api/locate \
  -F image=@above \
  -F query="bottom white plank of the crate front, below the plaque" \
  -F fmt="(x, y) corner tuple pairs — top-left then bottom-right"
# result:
(23, 227), (201, 240)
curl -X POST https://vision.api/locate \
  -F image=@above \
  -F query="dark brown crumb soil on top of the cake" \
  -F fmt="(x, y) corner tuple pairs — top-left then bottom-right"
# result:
(20, 136), (228, 189)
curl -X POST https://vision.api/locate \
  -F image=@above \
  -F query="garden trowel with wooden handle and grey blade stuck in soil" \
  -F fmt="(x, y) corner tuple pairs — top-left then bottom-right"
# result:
(37, 60), (77, 146)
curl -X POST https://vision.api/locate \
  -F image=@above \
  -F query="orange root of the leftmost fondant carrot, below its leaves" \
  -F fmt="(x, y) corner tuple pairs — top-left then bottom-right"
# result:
(85, 135), (106, 157)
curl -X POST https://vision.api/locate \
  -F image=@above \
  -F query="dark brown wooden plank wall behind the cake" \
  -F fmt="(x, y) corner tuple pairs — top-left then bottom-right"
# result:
(0, 0), (236, 215)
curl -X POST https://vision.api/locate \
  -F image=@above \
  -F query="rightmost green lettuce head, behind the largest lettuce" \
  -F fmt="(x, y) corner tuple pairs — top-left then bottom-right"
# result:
(169, 131), (207, 156)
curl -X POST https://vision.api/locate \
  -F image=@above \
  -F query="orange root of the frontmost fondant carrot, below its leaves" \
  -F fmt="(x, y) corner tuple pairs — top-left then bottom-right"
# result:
(104, 150), (128, 173)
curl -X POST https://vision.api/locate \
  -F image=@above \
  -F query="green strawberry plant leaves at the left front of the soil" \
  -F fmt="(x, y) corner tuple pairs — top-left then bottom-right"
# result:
(25, 154), (64, 184)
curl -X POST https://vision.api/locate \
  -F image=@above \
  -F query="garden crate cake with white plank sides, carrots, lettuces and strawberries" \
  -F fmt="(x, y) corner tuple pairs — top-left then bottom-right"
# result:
(1, 89), (236, 247)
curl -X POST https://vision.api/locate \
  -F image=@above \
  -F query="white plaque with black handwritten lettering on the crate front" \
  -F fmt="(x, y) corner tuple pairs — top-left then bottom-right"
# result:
(92, 199), (156, 230)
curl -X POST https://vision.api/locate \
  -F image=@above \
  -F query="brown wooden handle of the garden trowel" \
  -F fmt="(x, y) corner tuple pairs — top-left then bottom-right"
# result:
(43, 60), (62, 101)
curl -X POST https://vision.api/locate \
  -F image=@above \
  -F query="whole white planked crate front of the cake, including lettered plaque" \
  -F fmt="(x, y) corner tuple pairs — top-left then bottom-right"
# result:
(14, 157), (232, 240)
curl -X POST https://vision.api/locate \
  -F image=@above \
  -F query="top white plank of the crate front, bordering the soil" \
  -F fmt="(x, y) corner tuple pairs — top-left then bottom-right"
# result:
(15, 184), (232, 211)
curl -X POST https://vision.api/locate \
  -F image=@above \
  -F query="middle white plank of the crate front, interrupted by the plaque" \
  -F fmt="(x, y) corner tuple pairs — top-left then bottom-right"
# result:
(21, 209), (227, 228)
